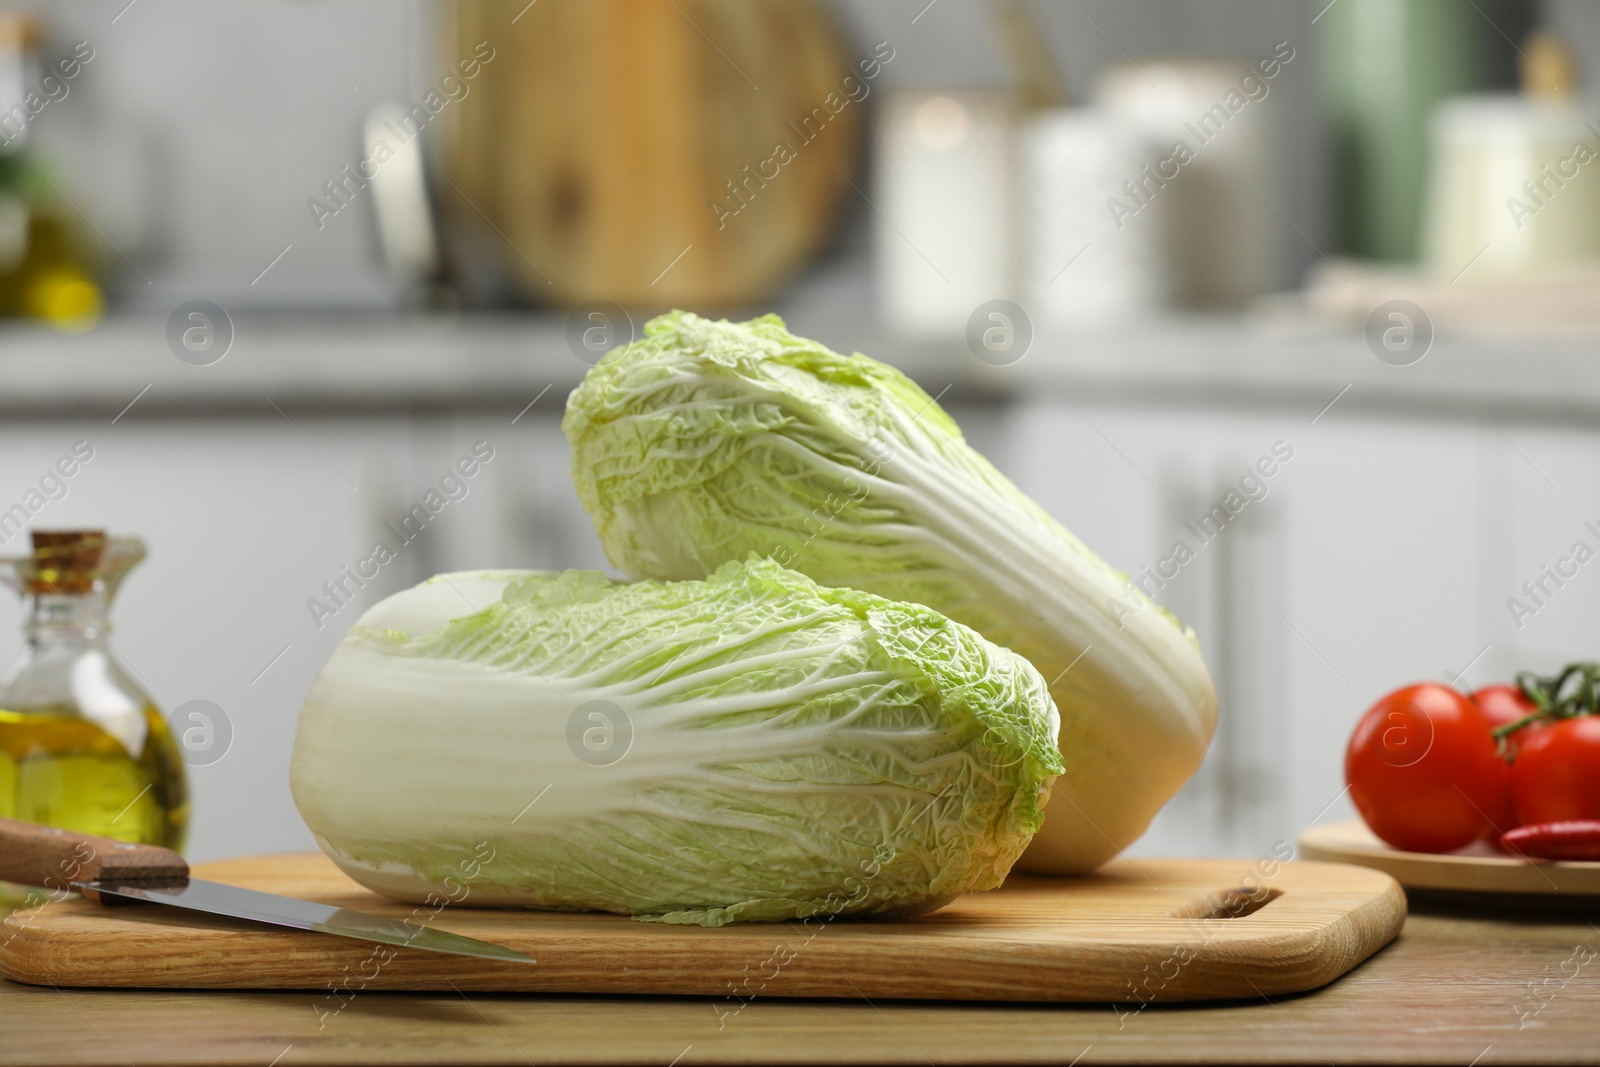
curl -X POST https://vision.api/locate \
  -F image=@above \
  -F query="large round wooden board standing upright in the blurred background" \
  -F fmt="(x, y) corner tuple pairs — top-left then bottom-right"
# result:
(440, 0), (864, 307)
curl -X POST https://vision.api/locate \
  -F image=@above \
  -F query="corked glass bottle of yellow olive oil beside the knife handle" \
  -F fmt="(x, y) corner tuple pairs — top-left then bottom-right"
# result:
(0, 530), (189, 908)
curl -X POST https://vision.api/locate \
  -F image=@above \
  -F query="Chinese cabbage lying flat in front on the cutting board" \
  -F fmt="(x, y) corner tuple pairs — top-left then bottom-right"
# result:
(291, 560), (1061, 926)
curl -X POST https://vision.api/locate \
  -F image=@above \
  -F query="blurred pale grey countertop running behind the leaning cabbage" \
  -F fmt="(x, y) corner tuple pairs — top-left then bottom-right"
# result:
(0, 307), (1600, 424)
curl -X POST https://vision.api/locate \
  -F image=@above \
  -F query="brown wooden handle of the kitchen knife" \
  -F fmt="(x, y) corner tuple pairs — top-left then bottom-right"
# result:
(0, 819), (189, 899)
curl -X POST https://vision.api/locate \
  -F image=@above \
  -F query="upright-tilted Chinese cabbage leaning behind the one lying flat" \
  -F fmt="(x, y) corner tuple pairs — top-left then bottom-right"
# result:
(563, 312), (1216, 873)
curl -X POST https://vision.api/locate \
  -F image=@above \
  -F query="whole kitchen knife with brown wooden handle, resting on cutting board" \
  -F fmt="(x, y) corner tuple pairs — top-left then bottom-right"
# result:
(0, 819), (534, 963)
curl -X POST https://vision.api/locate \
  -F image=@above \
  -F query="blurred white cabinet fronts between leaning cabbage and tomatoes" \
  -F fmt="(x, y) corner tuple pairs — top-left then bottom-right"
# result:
(994, 392), (1600, 856)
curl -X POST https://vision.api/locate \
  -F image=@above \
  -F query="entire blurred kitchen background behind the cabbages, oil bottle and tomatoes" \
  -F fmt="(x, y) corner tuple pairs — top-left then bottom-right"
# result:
(0, 0), (1600, 859)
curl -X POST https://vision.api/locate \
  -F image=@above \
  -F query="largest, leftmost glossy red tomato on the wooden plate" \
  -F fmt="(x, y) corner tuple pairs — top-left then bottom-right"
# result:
(1344, 683), (1510, 853)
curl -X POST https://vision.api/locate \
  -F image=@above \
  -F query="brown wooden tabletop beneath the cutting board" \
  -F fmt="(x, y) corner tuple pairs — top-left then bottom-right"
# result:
(0, 902), (1600, 1067)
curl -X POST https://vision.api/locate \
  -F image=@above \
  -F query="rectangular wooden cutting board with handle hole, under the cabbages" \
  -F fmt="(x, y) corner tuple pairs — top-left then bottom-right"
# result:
(0, 853), (1405, 1011)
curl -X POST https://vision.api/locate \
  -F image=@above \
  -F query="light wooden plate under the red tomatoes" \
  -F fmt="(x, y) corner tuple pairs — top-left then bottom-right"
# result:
(1299, 819), (1600, 897)
